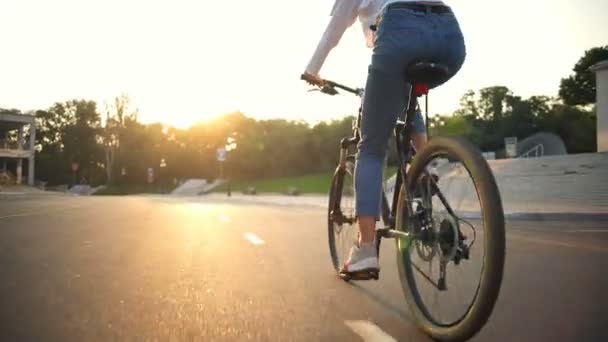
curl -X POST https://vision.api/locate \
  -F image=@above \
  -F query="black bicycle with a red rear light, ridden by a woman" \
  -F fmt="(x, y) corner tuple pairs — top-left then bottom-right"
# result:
(301, 62), (505, 341)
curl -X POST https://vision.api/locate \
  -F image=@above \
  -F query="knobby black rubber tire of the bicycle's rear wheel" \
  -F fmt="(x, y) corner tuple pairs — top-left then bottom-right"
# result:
(396, 137), (505, 341)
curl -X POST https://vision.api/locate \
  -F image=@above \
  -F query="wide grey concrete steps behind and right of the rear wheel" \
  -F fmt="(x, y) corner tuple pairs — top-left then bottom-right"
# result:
(385, 153), (608, 213)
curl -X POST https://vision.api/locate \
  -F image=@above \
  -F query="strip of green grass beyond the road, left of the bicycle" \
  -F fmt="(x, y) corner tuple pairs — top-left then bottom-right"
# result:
(215, 167), (396, 194)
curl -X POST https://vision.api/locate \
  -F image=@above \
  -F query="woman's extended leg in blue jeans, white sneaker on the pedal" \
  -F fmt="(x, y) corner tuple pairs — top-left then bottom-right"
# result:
(345, 4), (460, 272)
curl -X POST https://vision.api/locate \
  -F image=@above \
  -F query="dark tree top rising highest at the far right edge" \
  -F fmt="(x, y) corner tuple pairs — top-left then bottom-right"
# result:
(559, 45), (608, 106)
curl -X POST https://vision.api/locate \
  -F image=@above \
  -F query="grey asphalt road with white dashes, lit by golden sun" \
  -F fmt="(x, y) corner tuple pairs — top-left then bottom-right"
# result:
(0, 197), (608, 341)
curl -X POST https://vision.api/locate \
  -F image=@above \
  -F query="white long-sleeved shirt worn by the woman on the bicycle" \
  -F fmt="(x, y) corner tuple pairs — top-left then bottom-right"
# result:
(306, 0), (443, 75)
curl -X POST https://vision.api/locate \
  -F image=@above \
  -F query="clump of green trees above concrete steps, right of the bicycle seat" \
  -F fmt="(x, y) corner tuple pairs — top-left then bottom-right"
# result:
(444, 86), (596, 153)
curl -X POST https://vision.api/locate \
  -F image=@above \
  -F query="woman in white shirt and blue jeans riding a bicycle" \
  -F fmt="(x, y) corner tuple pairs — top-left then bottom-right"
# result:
(305, 0), (465, 274)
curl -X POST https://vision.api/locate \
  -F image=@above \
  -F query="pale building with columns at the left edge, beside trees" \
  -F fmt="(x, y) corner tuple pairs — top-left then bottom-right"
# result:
(0, 111), (36, 185)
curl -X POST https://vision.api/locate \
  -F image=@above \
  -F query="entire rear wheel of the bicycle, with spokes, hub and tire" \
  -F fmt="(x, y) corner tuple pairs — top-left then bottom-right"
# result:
(396, 137), (505, 341)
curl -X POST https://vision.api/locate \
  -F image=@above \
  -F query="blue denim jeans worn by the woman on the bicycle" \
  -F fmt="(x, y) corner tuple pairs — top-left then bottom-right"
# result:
(355, 6), (466, 217)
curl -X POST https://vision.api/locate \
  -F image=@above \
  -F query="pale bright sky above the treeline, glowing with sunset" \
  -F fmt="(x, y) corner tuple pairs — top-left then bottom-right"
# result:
(0, 0), (608, 127)
